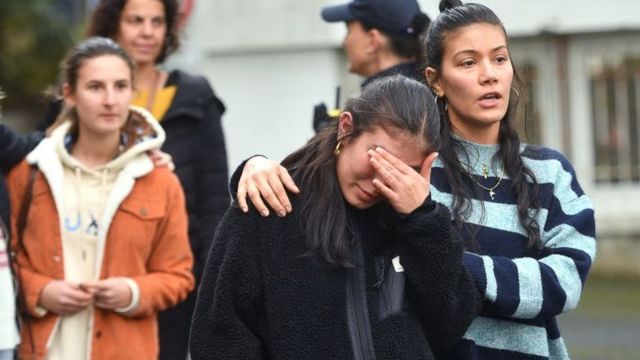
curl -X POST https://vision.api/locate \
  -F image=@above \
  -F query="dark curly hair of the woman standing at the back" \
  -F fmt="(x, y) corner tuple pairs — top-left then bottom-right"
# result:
(87, 0), (180, 64)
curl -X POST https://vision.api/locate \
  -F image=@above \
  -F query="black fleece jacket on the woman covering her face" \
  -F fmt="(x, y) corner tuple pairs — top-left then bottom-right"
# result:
(190, 198), (480, 360)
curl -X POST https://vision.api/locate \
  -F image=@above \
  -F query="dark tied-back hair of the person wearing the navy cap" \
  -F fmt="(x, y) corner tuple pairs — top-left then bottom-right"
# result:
(360, 12), (431, 59)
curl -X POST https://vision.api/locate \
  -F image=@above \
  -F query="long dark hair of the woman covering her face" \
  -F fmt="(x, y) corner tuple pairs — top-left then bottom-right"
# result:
(282, 75), (440, 267)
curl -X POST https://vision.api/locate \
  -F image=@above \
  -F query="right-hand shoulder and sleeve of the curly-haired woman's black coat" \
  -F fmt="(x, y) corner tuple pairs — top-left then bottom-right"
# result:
(160, 70), (230, 277)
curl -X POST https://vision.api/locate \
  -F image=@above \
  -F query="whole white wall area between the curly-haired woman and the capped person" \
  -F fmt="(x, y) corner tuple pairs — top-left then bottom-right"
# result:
(171, 0), (358, 169)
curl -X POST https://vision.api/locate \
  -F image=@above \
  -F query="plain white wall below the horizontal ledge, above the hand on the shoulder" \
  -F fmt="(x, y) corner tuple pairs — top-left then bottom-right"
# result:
(203, 50), (348, 169)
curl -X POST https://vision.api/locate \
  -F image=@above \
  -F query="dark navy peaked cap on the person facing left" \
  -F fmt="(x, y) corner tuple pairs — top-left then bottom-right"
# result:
(321, 0), (422, 35)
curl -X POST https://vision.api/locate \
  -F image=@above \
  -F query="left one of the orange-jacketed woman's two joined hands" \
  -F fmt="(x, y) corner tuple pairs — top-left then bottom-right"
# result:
(38, 280), (93, 315)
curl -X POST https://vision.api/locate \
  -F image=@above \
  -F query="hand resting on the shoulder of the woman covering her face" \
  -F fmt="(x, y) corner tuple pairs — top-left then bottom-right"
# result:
(238, 156), (300, 217)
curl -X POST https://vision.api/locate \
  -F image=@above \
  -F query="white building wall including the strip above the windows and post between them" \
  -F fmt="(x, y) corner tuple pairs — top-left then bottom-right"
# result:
(175, 0), (640, 168)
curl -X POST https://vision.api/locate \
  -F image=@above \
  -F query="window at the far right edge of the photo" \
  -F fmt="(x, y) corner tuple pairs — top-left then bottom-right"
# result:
(590, 57), (640, 183)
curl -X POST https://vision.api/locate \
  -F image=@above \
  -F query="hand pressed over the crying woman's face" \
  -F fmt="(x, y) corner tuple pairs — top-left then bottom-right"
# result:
(367, 147), (438, 214)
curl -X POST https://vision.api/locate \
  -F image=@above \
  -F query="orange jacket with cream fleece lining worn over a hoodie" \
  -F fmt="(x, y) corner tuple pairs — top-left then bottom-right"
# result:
(7, 150), (194, 360)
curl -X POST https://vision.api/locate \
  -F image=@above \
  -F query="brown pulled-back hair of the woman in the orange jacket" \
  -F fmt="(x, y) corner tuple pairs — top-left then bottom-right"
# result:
(47, 37), (148, 148)
